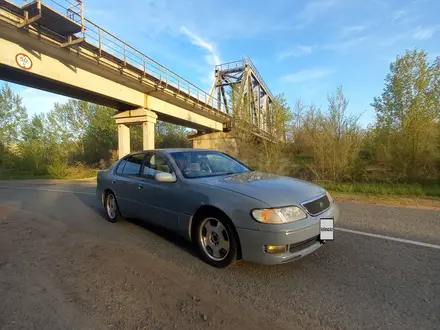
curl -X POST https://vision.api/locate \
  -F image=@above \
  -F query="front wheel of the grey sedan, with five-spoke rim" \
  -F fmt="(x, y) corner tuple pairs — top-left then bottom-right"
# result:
(195, 214), (238, 268)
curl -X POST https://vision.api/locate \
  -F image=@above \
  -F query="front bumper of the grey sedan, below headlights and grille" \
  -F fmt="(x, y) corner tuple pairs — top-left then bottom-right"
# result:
(237, 203), (339, 265)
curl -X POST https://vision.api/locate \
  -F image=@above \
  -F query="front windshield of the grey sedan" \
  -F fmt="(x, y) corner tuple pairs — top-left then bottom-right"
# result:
(171, 151), (250, 178)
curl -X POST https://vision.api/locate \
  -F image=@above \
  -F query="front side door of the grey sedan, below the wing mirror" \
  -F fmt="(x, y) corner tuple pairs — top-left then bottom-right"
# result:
(138, 152), (179, 230)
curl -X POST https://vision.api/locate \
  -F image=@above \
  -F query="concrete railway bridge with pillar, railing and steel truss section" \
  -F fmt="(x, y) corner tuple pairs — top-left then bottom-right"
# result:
(0, 0), (273, 157)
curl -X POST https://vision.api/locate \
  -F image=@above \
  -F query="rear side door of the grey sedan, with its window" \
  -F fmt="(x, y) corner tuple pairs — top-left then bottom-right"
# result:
(112, 153), (145, 218)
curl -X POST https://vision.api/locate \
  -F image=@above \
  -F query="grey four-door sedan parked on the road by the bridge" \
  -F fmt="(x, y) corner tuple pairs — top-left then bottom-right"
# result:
(96, 149), (339, 267)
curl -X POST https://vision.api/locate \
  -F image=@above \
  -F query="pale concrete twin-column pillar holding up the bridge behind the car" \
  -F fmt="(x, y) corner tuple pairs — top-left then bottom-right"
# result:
(114, 108), (157, 158)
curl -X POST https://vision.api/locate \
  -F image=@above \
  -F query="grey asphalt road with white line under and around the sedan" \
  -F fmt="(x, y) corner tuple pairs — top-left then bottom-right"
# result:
(0, 181), (440, 329)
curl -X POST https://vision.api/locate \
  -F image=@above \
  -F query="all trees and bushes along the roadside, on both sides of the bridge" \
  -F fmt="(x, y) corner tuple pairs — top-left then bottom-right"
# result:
(0, 49), (440, 197)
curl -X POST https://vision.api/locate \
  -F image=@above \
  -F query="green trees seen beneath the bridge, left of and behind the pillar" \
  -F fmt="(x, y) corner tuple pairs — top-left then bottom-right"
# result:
(0, 93), (191, 177)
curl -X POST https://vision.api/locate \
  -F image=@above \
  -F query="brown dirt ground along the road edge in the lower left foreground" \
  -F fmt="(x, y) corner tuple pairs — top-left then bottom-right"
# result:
(0, 206), (300, 329)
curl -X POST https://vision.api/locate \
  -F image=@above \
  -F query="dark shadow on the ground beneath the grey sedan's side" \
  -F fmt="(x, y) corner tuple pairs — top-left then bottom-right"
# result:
(77, 194), (198, 257)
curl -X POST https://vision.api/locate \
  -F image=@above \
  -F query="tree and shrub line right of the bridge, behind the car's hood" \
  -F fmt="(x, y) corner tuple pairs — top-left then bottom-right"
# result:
(217, 49), (440, 184)
